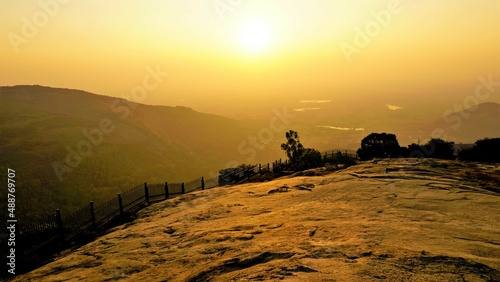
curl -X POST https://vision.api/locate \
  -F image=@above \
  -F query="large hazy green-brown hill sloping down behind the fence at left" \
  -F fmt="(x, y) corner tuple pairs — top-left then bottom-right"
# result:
(0, 86), (279, 220)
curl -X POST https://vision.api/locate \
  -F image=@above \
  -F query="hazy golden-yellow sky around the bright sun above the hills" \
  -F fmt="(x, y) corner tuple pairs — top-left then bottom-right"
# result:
(0, 0), (500, 114)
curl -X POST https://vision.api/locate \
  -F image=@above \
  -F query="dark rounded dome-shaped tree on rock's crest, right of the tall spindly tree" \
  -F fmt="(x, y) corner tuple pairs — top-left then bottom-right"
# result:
(357, 133), (400, 160)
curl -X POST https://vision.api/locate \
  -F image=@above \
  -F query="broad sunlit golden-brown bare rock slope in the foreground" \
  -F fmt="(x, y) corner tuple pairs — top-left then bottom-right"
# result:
(14, 159), (500, 281)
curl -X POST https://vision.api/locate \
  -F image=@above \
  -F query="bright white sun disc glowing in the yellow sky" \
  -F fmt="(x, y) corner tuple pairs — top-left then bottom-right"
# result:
(240, 20), (270, 52)
